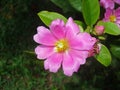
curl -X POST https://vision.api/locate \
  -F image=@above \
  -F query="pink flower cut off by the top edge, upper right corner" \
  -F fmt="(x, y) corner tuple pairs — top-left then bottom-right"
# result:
(100, 0), (120, 9)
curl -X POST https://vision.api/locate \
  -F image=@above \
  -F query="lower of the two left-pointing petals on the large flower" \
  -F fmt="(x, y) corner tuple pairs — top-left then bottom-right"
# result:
(35, 45), (54, 59)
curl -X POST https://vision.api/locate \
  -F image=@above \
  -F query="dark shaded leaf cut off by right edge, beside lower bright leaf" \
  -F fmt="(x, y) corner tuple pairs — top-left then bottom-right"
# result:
(110, 45), (120, 59)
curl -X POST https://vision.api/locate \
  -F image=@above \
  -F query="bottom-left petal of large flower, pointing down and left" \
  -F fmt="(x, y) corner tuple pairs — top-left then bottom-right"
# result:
(44, 53), (63, 73)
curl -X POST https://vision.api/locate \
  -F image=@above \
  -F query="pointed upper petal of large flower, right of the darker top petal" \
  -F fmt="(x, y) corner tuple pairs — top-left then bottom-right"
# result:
(66, 17), (80, 34)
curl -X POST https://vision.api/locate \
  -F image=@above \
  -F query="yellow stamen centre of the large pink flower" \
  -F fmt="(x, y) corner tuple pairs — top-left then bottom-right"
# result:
(55, 39), (69, 53)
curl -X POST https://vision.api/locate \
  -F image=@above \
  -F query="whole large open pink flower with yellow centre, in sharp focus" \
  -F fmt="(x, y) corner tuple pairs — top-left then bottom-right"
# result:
(34, 18), (96, 76)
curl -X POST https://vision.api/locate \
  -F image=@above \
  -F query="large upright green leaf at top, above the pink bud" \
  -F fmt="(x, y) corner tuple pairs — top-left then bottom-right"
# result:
(82, 0), (100, 26)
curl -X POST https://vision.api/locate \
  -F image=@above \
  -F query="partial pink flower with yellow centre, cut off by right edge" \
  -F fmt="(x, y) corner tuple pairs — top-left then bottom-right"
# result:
(103, 7), (120, 26)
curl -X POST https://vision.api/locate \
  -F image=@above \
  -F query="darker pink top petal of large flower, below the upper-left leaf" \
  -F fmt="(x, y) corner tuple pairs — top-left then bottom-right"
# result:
(50, 19), (65, 39)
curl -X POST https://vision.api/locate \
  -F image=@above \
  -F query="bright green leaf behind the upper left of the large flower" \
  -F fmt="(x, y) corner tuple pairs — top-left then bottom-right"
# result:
(38, 11), (67, 26)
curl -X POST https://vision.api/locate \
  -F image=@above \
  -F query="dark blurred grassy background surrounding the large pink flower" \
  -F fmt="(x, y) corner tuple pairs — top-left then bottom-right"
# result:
(0, 0), (120, 90)
